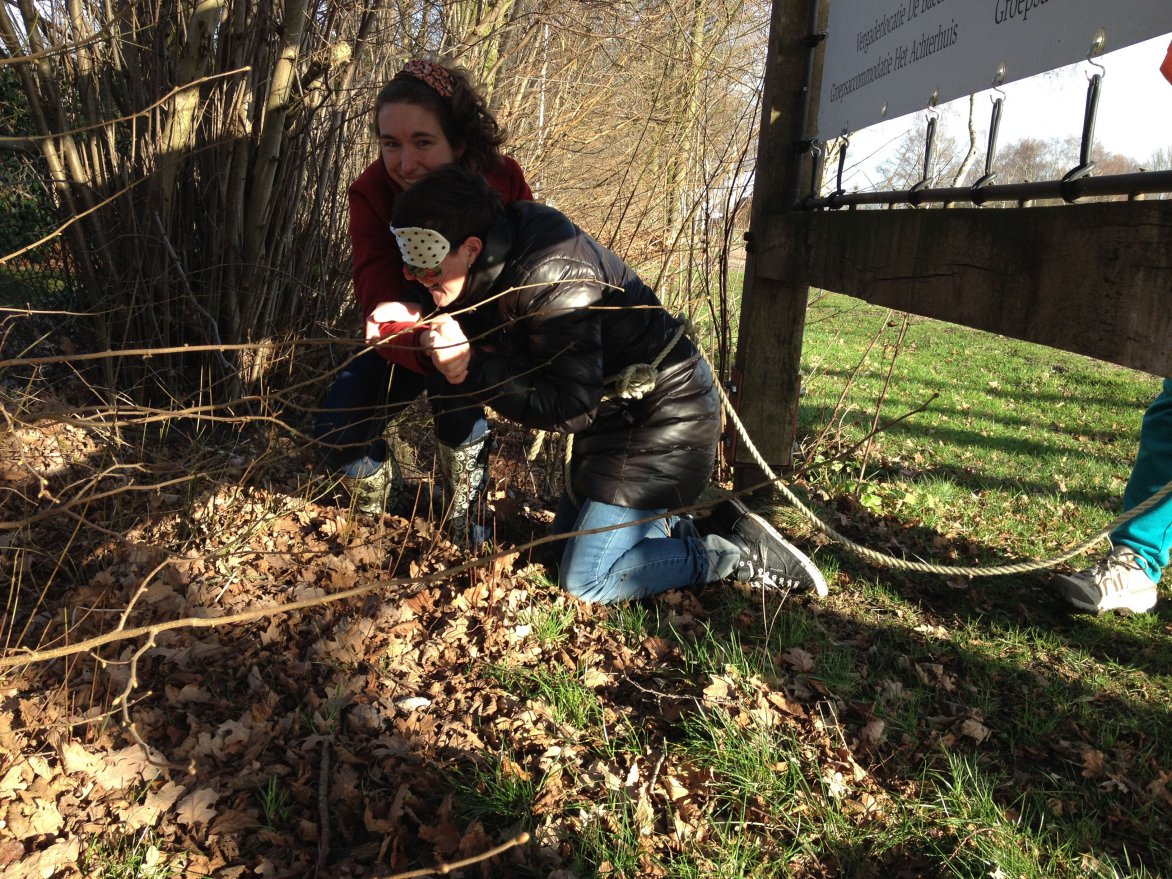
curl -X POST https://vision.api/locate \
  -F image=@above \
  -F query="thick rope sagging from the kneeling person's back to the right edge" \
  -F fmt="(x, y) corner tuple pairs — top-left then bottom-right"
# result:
(700, 350), (1172, 577)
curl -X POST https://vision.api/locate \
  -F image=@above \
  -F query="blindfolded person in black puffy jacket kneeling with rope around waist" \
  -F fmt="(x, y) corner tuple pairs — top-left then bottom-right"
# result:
(391, 165), (826, 602)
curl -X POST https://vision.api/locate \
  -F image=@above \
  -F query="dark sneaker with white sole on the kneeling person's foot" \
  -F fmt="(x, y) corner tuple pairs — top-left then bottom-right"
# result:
(711, 498), (830, 597)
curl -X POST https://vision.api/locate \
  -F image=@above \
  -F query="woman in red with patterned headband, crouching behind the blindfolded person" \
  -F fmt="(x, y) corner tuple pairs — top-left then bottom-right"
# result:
(314, 60), (533, 545)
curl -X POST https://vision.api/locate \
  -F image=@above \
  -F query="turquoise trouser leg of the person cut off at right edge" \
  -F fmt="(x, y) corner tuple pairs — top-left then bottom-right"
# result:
(1111, 379), (1172, 582)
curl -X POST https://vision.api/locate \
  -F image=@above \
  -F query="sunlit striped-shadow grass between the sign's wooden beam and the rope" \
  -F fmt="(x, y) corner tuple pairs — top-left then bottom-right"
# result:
(799, 294), (1159, 556)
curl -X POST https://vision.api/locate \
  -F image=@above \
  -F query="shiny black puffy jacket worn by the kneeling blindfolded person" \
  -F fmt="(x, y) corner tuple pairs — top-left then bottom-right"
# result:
(448, 202), (720, 510)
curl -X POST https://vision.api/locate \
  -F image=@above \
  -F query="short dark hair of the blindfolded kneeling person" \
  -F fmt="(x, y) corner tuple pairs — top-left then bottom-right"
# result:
(393, 164), (505, 250)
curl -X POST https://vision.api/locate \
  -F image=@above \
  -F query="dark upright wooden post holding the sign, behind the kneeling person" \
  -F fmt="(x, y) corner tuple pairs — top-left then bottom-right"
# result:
(733, 0), (826, 489)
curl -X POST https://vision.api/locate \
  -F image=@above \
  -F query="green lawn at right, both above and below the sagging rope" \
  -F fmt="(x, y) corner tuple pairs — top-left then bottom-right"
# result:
(690, 294), (1172, 878)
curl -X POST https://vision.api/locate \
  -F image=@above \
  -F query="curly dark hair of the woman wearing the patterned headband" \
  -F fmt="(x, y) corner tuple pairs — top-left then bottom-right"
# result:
(374, 61), (507, 173)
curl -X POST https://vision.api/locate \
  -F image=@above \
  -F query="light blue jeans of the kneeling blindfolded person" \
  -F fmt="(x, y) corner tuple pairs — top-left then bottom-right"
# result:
(553, 495), (711, 605)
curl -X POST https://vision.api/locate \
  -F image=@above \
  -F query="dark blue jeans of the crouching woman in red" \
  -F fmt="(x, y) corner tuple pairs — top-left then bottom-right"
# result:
(313, 350), (489, 477)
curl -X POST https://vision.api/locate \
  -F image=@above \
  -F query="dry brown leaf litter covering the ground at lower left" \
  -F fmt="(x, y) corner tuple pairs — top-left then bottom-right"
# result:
(0, 403), (874, 877)
